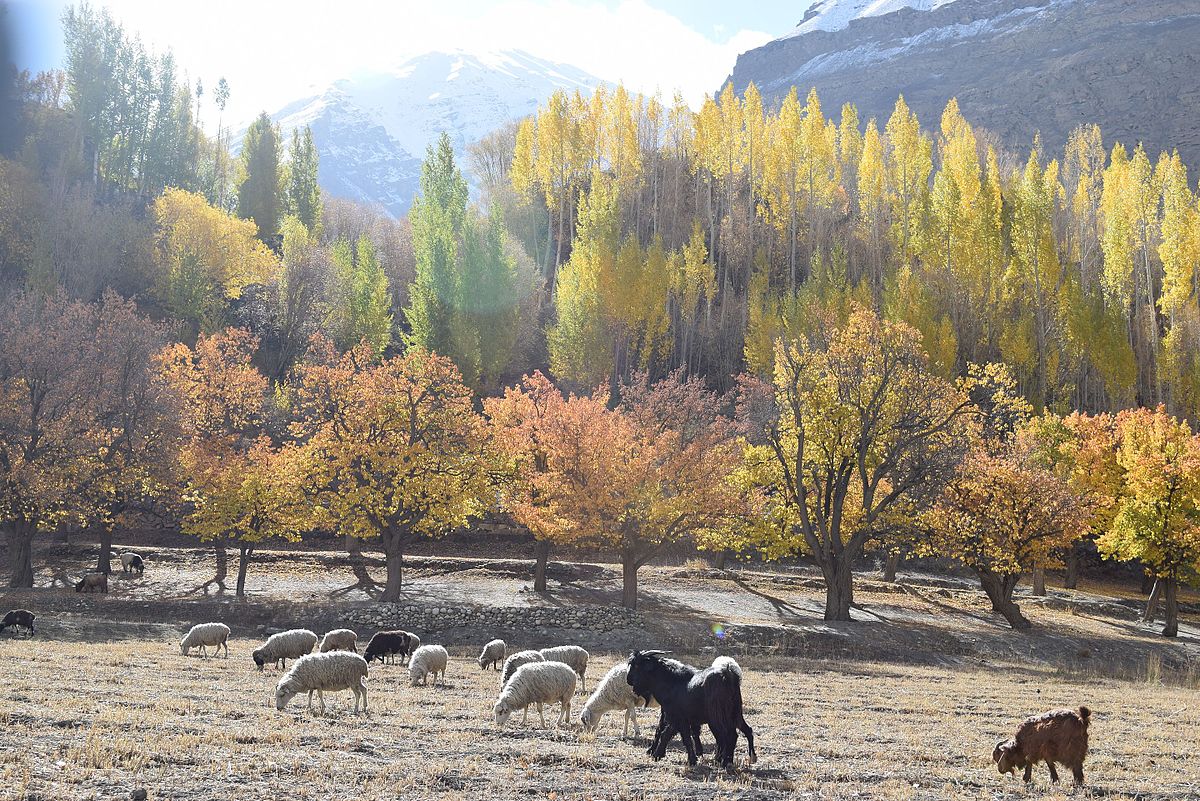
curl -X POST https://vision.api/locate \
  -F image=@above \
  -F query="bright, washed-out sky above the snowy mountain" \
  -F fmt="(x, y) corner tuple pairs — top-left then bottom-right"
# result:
(6, 0), (809, 127)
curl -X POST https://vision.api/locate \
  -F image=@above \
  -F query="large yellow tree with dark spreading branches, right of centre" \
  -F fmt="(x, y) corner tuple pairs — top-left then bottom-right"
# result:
(742, 306), (971, 620)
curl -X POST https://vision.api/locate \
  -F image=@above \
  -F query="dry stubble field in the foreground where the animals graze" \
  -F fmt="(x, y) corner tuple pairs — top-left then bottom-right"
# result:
(0, 637), (1200, 801)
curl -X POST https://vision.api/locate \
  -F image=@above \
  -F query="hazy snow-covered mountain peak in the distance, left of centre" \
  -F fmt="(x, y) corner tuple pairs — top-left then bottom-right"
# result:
(246, 50), (602, 216)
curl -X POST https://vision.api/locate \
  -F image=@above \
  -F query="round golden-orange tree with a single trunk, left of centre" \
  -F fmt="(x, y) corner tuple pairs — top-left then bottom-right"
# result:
(289, 342), (491, 601)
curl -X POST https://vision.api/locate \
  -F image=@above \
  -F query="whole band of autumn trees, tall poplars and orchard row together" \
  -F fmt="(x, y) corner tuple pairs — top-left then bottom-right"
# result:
(0, 5), (1200, 633)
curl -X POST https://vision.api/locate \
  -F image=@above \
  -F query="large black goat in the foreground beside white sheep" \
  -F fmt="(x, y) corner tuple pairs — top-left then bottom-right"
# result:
(628, 651), (758, 767)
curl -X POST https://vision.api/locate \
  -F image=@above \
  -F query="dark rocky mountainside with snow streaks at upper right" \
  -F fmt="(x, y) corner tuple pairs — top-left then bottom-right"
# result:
(730, 0), (1200, 169)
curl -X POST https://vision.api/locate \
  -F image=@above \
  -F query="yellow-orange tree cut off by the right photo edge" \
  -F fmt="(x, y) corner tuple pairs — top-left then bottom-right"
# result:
(1096, 406), (1200, 637)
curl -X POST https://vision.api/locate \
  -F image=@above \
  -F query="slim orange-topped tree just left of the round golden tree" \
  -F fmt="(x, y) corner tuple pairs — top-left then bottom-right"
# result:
(158, 329), (269, 595)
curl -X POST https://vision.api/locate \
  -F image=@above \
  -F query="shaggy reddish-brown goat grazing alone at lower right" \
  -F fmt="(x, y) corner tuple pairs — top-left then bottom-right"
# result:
(991, 706), (1092, 785)
